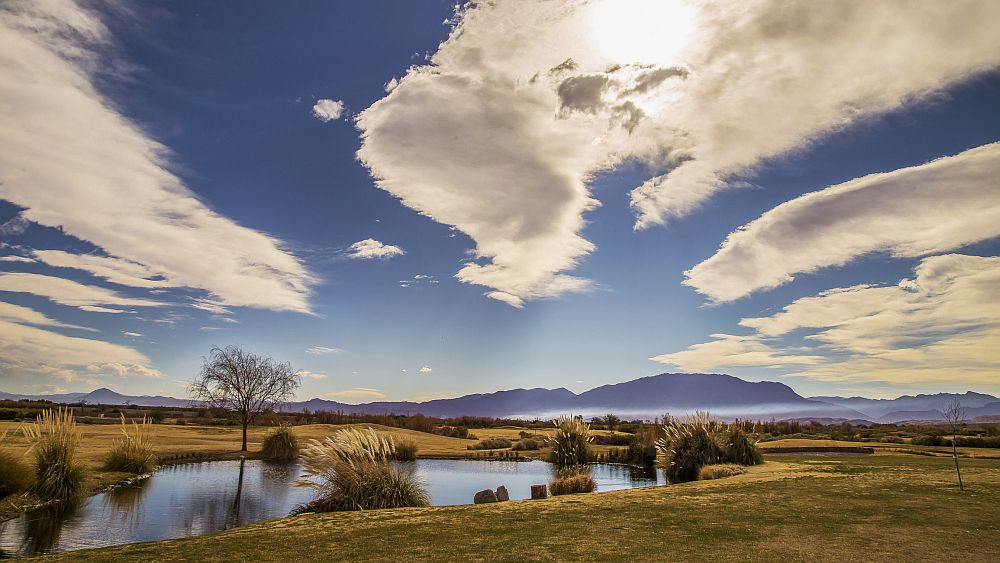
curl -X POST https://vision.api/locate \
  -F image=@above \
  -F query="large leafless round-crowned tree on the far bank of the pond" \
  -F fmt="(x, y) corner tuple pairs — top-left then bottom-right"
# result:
(191, 346), (301, 452)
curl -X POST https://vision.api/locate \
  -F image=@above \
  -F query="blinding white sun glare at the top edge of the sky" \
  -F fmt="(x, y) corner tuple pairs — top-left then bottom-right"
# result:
(587, 0), (694, 65)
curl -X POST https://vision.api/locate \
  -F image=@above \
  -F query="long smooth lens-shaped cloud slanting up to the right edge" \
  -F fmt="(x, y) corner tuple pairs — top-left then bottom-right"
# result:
(684, 143), (1000, 301)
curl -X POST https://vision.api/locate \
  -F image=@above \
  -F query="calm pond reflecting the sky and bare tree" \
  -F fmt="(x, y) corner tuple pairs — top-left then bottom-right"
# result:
(0, 459), (666, 557)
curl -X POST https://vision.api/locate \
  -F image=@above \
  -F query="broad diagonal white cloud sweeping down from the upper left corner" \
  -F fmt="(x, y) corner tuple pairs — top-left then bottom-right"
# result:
(0, 0), (314, 312)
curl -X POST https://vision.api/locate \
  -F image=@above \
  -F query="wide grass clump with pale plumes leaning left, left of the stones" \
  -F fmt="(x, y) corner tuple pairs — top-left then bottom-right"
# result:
(297, 428), (429, 512)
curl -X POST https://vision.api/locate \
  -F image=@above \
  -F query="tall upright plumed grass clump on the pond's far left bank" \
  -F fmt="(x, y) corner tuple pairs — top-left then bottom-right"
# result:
(25, 408), (87, 502)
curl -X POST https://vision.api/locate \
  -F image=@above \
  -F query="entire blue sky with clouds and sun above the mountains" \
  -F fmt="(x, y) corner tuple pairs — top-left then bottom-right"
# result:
(0, 0), (1000, 403)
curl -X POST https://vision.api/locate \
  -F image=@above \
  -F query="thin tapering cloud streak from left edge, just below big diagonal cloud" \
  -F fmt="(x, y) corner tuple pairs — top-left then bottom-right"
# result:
(0, 272), (166, 313)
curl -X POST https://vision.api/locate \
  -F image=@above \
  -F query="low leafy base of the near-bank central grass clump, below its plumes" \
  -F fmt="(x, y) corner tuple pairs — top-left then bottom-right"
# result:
(296, 461), (430, 513)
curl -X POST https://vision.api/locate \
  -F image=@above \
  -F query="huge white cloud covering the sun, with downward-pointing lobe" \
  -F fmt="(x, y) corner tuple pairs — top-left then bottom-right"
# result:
(357, 0), (1000, 306)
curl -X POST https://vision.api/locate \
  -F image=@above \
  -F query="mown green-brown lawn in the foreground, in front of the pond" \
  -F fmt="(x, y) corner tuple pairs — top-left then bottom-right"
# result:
(29, 455), (1000, 562)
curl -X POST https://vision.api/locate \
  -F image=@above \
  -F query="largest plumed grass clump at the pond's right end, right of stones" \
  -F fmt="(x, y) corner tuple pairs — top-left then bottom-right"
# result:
(656, 411), (724, 481)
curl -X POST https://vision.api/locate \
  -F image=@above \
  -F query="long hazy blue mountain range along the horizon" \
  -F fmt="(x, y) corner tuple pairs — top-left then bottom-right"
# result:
(0, 373), (1000, 423)
